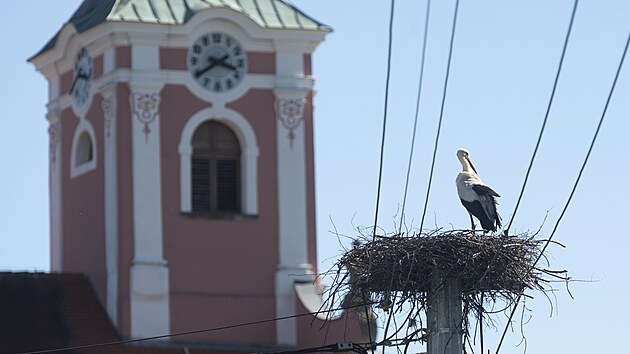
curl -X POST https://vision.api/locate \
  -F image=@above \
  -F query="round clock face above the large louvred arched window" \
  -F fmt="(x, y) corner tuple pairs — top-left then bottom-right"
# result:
(188, 32), (247, 92)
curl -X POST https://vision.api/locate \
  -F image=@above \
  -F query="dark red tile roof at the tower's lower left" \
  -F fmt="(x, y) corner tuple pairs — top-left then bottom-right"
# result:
(0, 272), (262, 354)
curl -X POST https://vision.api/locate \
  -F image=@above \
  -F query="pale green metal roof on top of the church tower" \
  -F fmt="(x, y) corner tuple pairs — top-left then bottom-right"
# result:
(34, 0), (331, 57)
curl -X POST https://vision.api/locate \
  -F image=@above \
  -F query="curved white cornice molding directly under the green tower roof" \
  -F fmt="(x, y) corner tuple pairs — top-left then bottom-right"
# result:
(29, 8), (329, 77)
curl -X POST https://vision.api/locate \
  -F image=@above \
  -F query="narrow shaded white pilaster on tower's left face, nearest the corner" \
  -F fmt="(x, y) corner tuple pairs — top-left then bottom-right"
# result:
(101, 85), (118, 325)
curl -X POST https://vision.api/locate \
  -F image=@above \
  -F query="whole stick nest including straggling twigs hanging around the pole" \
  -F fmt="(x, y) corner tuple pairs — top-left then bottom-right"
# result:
(327, 230), (569, 343)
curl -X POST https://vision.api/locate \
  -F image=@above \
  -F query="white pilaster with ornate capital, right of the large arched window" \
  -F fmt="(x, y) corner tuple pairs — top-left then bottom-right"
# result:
(274, 86), (312, 346)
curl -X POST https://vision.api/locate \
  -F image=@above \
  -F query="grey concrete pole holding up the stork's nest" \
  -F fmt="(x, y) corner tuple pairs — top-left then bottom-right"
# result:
(427, 276), (464, 354)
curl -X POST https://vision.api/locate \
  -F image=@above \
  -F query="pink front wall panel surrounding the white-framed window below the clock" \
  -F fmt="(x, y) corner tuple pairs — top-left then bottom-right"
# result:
(160, 86), (278, 344)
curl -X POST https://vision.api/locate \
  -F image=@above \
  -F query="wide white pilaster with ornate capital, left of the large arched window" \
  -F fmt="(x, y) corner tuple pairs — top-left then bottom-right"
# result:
(129, 88), (170, 338)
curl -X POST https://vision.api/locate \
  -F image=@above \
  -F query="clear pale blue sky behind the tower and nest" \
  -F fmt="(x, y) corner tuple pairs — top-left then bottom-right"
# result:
(0, 0), (630, 353)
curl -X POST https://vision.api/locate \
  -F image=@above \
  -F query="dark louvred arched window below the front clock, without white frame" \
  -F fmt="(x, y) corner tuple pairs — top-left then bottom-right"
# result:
(191, 120), (241, 213)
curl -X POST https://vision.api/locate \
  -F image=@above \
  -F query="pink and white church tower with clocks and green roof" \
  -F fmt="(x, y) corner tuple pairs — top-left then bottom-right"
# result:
(30, 0), (373, 346)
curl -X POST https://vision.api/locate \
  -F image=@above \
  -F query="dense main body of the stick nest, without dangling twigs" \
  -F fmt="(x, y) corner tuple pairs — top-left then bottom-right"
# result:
(340, 231), (540, 294)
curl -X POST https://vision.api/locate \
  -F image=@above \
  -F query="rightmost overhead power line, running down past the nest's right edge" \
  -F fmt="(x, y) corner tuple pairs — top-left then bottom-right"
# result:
(496, 25), (630, 354)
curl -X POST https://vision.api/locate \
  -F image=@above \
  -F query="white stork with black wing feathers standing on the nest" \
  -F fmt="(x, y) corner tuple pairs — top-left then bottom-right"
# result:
(455, 149), (501, 232)
